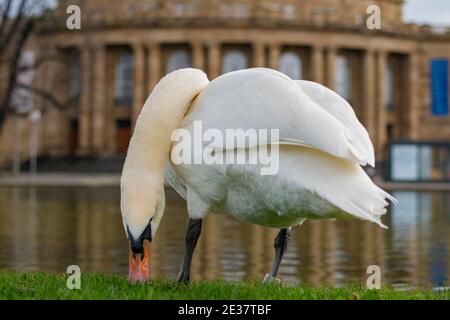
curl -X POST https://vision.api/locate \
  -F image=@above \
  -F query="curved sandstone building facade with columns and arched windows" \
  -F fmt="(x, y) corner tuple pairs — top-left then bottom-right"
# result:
(0, 0), (450, 172)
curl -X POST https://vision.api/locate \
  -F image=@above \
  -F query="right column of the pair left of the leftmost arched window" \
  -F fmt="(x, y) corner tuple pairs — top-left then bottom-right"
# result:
(91, 45), (106, 155)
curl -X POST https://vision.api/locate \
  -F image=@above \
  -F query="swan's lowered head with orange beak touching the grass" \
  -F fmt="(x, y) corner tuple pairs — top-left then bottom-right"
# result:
(120, 173), (165, 283)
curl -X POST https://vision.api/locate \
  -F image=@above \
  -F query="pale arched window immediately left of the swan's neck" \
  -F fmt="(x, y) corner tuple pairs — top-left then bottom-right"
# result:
(115, 52), (133, 105)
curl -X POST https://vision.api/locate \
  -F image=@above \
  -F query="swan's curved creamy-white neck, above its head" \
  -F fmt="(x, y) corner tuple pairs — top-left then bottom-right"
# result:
(122, 68), (209, 183)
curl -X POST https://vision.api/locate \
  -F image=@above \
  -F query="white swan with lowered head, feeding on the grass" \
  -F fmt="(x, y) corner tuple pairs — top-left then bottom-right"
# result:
(121, 68), (395, 282)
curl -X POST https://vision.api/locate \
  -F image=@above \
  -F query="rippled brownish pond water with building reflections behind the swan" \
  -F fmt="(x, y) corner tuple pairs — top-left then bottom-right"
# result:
(0, 188), (450, 286)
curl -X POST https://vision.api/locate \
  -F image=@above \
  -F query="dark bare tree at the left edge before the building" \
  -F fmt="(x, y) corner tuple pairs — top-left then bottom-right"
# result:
(0, 0), (67, 133)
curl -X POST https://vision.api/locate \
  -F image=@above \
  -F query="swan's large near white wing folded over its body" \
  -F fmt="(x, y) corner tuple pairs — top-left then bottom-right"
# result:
(182, 68), (372, 165)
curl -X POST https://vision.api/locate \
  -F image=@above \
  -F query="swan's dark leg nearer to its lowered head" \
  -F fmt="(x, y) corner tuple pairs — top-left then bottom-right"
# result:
(177, 219), (202, 282)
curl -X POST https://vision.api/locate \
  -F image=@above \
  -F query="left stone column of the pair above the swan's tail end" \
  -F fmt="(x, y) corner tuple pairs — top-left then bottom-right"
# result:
(362, 49), (376, 140)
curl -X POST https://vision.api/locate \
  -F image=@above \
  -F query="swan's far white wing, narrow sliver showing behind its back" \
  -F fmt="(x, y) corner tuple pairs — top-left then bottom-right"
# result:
(295, 80), (375, 167)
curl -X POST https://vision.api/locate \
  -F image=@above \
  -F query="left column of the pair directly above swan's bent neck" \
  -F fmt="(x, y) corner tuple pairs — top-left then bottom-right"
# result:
(132, 44), (147, 127)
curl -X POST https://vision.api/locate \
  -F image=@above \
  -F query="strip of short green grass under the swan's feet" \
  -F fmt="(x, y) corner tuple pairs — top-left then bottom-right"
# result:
(0, 271), (450, 300)
